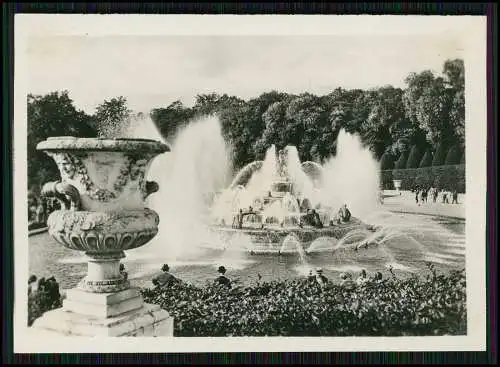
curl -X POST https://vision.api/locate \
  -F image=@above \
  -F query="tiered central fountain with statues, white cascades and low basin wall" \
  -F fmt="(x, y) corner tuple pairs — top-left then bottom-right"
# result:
(212, 145), (370, 255)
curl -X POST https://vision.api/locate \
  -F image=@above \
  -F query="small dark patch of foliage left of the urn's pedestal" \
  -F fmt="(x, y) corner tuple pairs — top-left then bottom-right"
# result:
(28, 277), (62, 326)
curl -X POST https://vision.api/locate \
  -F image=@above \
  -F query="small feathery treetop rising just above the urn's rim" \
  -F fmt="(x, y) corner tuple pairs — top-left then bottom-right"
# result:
(94, 96), (132, 138)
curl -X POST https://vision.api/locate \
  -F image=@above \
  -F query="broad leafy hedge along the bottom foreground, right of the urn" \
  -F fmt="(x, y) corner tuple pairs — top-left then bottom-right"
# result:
(142, 265), (466, 337)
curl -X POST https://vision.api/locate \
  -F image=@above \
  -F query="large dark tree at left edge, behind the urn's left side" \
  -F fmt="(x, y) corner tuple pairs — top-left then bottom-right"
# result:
(27, 91), (97, 191)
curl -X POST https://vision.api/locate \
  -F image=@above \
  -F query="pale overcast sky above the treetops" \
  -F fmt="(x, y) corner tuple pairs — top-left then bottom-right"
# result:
(28, 35), (463, 113)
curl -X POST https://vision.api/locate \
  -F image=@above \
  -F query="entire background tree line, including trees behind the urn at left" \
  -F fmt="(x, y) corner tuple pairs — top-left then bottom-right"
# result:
(28, 59), (465, 191)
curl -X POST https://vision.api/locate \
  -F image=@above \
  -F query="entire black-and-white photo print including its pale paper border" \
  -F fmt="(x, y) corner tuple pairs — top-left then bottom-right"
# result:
(14, 14), (487, 352)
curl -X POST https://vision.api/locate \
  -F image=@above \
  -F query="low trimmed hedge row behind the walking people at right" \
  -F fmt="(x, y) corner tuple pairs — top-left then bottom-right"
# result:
(381, 164), (465, 193)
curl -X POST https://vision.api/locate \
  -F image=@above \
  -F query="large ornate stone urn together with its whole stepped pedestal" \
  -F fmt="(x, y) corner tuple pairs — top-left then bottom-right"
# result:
(32, 137), (173, 336)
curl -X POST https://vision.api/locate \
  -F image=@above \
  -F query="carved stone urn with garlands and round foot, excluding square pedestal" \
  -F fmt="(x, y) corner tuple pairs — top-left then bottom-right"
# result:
(37, 137), (170, 293)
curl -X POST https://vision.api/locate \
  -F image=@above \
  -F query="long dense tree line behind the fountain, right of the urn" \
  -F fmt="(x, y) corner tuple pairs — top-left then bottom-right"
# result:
(151, 59), (465, 169)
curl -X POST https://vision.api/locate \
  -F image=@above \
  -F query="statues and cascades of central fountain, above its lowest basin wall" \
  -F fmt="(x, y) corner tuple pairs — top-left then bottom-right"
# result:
(211, 147), (331, 233)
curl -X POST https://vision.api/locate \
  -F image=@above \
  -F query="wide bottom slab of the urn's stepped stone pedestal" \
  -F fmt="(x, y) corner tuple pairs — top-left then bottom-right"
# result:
(32, 303), (174, 337)
